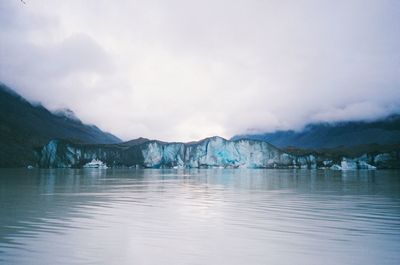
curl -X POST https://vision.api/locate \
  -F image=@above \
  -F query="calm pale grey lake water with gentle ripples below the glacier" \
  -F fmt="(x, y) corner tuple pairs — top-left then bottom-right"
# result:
(0, 169), (400, 265)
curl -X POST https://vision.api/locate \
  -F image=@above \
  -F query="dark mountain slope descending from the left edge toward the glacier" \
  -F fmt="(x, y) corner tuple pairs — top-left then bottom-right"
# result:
(0, 84), (121, 167)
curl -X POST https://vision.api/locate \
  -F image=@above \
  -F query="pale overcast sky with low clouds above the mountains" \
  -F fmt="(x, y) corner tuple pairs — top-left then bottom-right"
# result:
(0, 0), (400, 141)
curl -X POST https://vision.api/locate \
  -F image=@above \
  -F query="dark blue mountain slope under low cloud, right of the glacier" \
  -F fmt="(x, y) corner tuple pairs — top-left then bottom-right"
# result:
(232, 114), (400, 149)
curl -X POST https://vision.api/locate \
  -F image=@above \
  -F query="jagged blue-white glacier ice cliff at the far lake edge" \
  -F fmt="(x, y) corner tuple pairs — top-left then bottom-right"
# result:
(37, 137), (316, 168)
